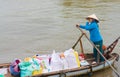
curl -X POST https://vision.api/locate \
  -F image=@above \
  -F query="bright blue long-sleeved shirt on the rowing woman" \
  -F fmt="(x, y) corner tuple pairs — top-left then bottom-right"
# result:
(80, 21), (103, 42)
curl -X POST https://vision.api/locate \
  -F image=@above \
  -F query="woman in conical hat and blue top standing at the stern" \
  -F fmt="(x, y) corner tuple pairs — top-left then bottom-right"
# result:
(76, 14), (104, 62)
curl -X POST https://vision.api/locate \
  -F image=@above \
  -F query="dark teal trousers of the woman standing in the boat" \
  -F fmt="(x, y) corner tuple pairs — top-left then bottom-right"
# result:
(93, 40), (104, 62)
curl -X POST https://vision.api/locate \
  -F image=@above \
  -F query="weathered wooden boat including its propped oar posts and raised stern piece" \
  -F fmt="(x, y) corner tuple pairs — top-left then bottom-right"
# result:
(0, 28), (120, 77)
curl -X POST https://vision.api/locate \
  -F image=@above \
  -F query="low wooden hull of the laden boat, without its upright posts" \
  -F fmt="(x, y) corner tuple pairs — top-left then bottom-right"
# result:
(0, 53), (119, 77)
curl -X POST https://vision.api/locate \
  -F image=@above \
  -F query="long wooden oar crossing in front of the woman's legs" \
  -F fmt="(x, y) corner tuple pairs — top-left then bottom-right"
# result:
(77, 27), (120, 77)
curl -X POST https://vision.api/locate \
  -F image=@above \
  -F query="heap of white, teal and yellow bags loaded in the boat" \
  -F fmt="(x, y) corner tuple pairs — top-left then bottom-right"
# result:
(9, 49), (89, 77)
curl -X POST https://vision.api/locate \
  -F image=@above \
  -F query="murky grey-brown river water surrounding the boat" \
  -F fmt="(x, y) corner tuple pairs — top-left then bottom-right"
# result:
(0, 0), (120, 77)
